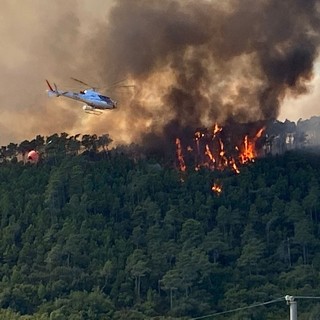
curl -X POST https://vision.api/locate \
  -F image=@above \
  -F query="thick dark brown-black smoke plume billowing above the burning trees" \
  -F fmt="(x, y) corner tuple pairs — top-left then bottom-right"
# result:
(91, 0), (320, 154)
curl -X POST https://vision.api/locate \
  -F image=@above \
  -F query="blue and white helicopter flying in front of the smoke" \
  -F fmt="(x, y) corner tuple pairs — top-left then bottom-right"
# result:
(46, 78), (129, 115)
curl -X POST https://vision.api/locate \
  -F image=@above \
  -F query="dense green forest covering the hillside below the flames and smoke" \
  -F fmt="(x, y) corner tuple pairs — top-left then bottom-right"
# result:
(0, 133), (320, 320)
